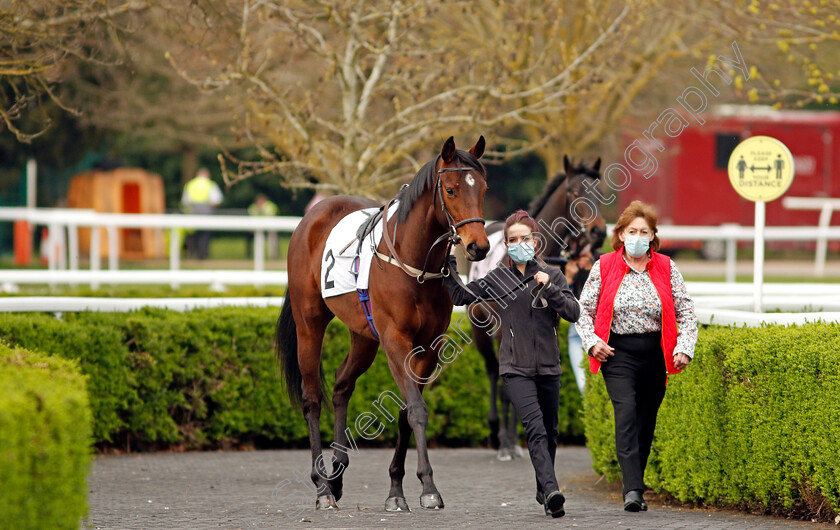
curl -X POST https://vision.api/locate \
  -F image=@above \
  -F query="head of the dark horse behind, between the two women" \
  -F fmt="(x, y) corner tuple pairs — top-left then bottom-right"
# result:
(563, 155), (607, 257)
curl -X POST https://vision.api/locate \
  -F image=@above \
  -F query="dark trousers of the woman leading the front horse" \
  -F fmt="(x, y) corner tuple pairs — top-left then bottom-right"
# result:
(502, 374), (560, 495)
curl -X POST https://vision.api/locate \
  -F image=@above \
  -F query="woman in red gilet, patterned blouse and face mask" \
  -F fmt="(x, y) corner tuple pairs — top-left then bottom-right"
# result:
(577, 201), (697, 512)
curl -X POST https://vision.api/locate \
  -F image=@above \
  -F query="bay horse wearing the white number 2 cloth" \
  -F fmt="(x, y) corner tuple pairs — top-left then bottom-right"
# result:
(275, 136), (489, 511)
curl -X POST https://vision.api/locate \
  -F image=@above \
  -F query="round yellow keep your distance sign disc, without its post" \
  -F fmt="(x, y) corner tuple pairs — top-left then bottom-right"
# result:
(727, 136), (794, 202)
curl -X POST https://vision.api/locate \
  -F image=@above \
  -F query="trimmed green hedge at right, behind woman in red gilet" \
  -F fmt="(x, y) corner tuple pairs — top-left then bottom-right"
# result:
(585, 324), (840, 518)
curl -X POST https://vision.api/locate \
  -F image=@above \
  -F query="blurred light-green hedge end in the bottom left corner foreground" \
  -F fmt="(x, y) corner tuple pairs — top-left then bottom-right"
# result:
(0, 343), (91, 529)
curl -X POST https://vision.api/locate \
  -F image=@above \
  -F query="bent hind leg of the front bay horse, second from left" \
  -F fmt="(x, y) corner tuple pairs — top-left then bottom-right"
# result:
(329, 331), (379, 501)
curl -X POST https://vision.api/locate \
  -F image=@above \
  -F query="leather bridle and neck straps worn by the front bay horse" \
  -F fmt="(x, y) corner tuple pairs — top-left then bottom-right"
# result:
(376, 166), (484, 284)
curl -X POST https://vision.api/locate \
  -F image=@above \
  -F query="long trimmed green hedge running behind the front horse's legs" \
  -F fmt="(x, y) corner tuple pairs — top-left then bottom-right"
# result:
(0, 308), (583, 449)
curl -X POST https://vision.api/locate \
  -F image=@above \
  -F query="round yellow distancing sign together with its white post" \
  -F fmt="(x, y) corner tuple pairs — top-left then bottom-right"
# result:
(727, 136), (794, 313)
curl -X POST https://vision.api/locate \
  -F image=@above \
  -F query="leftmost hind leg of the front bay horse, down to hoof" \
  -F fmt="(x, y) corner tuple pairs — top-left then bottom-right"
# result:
(295, 306), (338, 509)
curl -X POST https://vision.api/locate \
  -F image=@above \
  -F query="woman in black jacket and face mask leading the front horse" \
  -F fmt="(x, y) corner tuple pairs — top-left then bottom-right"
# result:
(445, 210), (580, 517)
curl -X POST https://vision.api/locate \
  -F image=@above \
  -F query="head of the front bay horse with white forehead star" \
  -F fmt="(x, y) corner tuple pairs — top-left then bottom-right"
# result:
(435, 136), (490, 261)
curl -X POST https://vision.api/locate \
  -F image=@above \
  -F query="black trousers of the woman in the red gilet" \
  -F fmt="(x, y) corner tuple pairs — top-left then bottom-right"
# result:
(601, 332), (666, 493)
